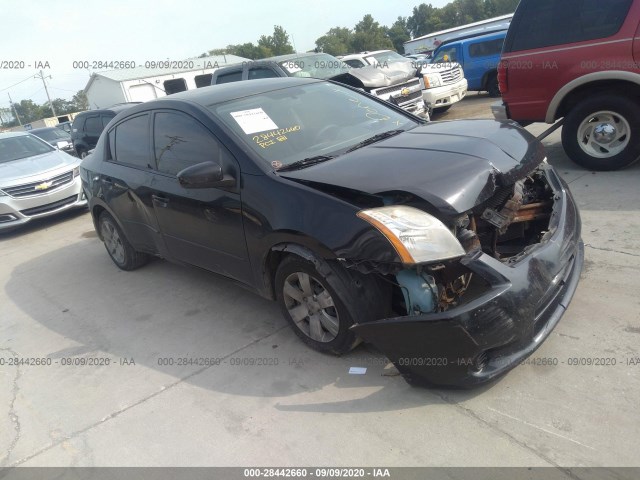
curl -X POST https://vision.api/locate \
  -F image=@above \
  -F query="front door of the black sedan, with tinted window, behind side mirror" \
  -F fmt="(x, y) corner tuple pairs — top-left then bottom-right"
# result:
(152, 110), (252, 283)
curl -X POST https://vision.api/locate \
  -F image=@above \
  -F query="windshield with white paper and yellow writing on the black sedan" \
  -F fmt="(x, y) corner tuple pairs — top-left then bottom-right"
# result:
(209, 82), (419, 169)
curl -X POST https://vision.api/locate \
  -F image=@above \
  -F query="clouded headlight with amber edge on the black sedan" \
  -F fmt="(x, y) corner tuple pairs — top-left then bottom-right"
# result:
(358, 205), (465, 264)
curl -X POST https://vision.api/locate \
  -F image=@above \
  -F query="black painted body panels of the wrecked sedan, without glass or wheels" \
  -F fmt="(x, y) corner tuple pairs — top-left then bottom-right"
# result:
(81, 79), (582, 385)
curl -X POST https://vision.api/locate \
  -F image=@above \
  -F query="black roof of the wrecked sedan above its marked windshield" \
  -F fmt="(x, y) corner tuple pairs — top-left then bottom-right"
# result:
(151, 77), (324, 107)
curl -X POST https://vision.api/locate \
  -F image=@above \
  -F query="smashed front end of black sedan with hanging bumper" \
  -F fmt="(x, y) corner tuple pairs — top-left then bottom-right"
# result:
(347, 163), (584, 386)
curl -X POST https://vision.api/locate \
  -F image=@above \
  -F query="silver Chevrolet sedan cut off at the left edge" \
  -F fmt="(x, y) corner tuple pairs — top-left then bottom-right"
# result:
(0, 132), (87, 231)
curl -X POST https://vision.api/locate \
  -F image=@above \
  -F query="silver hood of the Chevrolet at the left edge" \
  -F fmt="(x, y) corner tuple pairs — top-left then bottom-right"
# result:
(0, 150), (80, 187)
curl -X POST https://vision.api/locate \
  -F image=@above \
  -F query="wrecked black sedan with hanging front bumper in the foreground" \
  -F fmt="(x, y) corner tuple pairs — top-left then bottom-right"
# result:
(81, 78), (583, 386)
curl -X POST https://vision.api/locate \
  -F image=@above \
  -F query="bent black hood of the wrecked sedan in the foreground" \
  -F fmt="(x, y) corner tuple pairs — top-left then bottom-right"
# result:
(281, 120), (545, 216)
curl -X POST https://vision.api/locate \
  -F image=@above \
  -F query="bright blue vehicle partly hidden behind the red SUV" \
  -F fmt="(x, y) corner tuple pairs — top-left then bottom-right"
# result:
(431, 30), (507, 97)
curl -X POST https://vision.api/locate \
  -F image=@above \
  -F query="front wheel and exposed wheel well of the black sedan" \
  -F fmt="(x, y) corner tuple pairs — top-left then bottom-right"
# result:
(274, 255), (391, 355)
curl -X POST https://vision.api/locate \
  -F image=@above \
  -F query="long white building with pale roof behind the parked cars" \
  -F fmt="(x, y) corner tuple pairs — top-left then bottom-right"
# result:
(84, 55), (251, 110)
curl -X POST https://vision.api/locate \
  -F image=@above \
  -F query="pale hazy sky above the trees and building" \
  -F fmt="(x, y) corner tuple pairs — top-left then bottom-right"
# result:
(0, 0), (450, 112)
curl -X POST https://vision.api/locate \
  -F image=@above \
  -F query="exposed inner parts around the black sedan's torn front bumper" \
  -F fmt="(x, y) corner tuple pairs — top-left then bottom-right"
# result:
(394, 170), (554, 315)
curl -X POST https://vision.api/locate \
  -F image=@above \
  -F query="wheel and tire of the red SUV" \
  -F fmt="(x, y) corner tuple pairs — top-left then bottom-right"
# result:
(562, 95), (640, 171)
